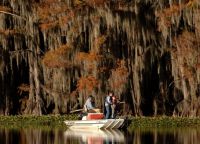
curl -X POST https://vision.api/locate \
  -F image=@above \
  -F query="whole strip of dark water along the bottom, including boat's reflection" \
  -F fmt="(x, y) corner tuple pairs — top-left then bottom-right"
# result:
(0, 128), (200, 144)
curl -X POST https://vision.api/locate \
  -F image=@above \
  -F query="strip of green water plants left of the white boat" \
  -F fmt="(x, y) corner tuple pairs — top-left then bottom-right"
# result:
(0, 115), (78, 129)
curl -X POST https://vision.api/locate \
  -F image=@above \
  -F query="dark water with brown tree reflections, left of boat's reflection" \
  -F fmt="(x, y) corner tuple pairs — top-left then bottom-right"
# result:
(0, 128), (67, 144)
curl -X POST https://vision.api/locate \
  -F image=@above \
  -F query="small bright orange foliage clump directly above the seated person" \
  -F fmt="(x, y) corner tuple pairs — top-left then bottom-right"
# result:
(77, 75), (99, 93)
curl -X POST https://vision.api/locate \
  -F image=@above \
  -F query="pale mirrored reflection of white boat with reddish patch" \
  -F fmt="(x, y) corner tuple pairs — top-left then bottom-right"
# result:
(64, 129), (125, 144)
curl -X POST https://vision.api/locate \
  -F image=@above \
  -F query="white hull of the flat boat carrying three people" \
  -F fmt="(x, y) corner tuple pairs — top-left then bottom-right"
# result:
(64, 113), (124, 129)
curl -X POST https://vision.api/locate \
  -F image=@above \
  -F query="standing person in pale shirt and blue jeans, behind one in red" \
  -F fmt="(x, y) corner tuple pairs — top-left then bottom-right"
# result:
(104, 92), (113, 119)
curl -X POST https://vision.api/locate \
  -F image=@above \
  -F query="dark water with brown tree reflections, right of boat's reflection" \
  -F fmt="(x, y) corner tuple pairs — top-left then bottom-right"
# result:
(126, 128), (200, 144)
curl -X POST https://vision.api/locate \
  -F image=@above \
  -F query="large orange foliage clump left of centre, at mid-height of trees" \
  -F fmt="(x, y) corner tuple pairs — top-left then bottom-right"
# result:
(43, 45), (72, 68)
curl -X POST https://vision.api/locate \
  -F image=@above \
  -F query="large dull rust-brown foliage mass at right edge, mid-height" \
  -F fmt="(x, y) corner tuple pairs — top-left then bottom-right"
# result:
(171, 31), (199, 80)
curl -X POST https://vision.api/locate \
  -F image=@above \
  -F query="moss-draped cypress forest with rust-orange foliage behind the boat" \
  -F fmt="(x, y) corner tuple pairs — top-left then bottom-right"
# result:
(0, 0), (200, 117)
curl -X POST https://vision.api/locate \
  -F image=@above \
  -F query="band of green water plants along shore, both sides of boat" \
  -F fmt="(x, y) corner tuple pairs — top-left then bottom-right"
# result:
(0, 115), (200, 130)
